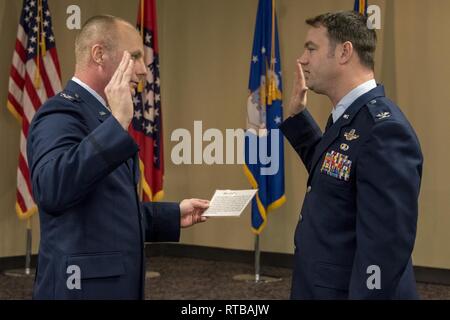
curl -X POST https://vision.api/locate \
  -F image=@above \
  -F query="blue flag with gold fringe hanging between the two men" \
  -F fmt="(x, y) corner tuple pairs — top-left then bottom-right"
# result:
(244, 0), (286, 234)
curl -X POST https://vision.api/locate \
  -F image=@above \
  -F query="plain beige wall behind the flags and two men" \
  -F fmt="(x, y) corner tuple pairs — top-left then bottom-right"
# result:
(0, 0), (450, 268)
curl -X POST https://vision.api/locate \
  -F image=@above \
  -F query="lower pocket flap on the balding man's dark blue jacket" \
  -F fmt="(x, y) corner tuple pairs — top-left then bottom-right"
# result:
(67, 252), (125, 279)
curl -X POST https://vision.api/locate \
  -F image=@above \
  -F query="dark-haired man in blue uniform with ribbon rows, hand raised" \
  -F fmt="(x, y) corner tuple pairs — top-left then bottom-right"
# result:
(281, 12), (423, 299)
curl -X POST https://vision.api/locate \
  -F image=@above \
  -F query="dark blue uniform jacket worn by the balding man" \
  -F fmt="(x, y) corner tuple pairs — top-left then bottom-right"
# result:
(27, 81), (180, 299)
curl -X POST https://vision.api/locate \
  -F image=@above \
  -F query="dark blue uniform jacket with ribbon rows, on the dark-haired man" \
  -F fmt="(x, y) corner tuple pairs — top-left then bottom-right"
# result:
(280, 86), (423, 299)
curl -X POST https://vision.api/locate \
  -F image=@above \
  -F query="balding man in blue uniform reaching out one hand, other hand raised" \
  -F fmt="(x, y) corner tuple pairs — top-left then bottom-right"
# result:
(27, 16), (208, 299)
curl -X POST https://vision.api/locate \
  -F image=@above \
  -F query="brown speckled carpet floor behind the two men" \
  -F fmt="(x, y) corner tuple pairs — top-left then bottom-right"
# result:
(0, 257), (450, 300)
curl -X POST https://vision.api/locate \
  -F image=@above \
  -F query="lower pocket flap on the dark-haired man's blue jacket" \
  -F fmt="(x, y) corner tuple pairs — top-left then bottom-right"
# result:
(314, 262), (352, 291)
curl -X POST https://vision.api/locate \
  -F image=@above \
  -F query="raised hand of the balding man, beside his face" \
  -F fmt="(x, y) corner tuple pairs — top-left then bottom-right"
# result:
(105, 51), (134, 130)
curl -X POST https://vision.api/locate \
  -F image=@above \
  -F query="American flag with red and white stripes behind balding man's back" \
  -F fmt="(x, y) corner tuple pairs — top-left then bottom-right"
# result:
(7, 0), (61, 219)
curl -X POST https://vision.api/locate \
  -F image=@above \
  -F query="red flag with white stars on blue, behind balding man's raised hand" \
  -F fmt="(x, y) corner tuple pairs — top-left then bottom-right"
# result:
(129, 0), (164, 201)
